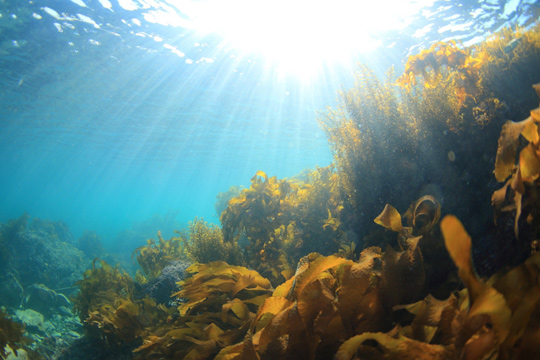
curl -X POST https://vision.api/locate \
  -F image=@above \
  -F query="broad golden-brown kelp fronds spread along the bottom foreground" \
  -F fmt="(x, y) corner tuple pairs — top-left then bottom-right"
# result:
(71, 215), (540, 360)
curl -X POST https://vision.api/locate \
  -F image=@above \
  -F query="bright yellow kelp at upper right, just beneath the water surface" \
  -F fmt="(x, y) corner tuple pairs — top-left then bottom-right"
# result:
(397, 25), (540, 127)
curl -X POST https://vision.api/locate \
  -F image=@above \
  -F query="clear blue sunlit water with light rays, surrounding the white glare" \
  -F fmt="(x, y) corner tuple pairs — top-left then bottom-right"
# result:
(0, 0), (540, 243)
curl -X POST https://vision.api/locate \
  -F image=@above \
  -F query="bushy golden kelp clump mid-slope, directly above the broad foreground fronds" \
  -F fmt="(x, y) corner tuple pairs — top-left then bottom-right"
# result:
(221, 166), (348, 284)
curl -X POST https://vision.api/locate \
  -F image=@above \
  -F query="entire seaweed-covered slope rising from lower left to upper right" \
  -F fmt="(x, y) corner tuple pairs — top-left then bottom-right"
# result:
(0, 27), (540, 360)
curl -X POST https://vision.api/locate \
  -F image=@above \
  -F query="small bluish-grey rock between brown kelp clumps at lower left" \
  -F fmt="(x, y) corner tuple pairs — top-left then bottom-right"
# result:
(144, 260), (191, 304)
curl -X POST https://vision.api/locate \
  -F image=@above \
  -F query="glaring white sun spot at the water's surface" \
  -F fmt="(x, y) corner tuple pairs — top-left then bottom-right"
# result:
(170, 0), (433, 76)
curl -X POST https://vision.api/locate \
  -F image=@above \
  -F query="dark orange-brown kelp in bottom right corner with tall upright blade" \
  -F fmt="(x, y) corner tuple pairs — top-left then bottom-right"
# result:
(335, 216), (540, 360)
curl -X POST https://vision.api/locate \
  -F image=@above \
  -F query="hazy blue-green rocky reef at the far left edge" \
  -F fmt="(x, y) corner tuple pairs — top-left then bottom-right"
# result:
(0, 214), (89, 359)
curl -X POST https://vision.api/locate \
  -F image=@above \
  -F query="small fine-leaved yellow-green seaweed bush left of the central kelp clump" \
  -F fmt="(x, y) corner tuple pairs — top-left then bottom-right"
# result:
(184, 218), (244, 265)
